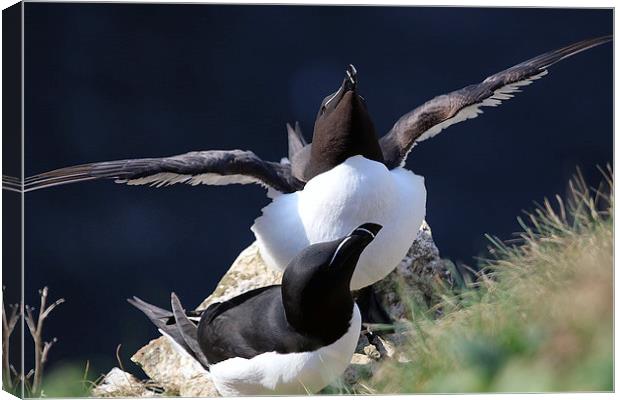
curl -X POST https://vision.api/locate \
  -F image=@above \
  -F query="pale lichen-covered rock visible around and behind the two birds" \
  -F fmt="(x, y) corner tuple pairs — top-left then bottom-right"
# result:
(93, 223), (451, 397)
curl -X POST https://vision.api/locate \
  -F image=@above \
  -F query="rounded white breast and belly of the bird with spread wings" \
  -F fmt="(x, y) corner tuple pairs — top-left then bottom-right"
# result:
(252, 156), (426, 290)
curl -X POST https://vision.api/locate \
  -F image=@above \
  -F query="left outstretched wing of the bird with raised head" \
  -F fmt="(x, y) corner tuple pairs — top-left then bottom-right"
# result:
(24, 150), (303, 193)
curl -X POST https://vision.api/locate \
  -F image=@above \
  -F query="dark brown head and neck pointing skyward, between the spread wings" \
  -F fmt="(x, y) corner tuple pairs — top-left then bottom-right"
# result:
(306, 65), (383, 176)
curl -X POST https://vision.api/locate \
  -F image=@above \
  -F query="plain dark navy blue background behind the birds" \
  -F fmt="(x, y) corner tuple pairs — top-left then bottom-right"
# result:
(25, 3), (613, 372)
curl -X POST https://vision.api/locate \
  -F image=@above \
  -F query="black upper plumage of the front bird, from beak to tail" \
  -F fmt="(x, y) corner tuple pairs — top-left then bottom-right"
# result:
(129, 223), (381, 367)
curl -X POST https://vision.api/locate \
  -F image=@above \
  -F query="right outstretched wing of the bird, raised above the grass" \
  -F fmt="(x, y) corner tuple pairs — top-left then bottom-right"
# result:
(380, 36), (612, 168)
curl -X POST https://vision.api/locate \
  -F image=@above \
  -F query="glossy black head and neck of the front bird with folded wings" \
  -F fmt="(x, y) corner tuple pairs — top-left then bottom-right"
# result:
(282, 223), (382, 340)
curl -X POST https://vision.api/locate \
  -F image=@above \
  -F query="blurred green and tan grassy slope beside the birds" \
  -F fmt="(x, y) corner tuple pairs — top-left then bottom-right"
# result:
(365, 170), (613, 393)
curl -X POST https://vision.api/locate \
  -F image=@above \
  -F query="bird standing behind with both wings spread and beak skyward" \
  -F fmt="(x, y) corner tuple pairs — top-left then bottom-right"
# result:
(24, 36), (612, 322)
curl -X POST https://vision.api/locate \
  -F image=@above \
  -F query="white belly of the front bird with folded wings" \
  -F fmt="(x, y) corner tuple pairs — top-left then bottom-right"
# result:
(210, 305), (362, 396)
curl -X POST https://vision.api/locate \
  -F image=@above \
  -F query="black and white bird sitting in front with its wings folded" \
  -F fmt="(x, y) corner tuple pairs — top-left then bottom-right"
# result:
(129, 223), (381, 396)
